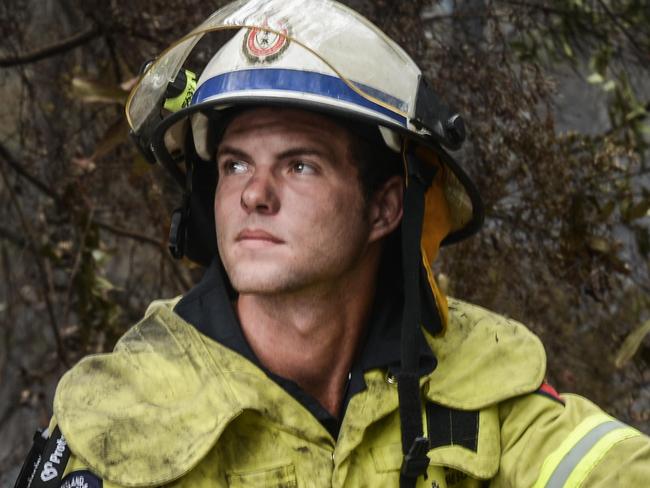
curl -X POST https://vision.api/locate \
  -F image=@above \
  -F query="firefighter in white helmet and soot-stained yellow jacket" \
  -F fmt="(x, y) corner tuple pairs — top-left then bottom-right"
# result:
(17, 0), (650, 488)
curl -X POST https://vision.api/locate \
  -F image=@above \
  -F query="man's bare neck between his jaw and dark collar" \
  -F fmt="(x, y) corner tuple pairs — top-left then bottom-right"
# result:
(236, 252), (377, 417)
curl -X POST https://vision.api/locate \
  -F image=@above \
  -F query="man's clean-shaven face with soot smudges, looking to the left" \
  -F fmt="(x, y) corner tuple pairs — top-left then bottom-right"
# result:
(215, 108), (371, 294)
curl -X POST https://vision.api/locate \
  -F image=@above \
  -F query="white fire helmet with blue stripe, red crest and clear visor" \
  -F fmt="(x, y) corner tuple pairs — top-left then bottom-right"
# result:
(126, 0), (482, 264)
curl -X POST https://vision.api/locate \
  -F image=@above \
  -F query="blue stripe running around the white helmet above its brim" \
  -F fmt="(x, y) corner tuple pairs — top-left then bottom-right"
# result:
(192, 68), (406, 126)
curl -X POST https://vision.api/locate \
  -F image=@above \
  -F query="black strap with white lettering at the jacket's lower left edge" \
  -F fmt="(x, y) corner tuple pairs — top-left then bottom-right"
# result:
(14, 427), (70, 488)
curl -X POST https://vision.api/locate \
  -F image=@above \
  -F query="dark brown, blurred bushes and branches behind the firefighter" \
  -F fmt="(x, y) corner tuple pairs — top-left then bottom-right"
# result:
(0, 0), (650, 480)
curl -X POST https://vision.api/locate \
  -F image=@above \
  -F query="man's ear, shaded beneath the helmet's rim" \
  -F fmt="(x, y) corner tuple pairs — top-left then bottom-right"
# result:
(368, 175), (404, 242)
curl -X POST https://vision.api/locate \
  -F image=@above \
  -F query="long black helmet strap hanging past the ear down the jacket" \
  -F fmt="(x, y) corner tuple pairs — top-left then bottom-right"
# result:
(397, 151), (437, 488)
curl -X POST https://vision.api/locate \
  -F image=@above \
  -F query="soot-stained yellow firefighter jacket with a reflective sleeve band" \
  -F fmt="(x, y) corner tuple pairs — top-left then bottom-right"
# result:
(13, 280), (650, 488)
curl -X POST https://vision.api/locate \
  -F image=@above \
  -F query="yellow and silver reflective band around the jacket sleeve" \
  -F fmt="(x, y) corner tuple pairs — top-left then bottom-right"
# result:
(534, 413), (641, 488)
